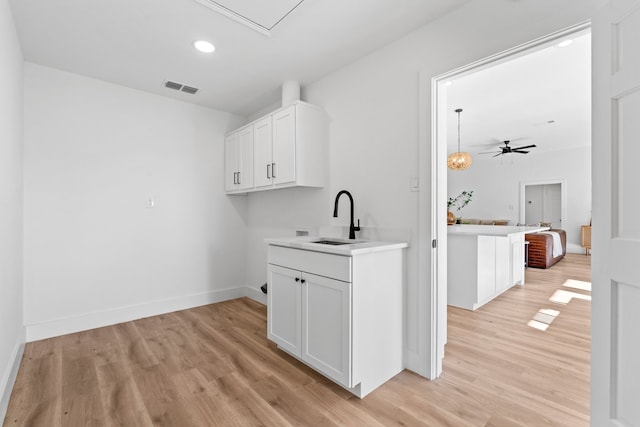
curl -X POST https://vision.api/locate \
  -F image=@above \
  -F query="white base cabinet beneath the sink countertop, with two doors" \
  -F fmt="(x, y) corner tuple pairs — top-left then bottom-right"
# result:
(267, 245), (403, 397)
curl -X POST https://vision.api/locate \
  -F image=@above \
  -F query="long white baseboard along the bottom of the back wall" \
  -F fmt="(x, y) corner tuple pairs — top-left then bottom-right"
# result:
(25, 287), (245, 342)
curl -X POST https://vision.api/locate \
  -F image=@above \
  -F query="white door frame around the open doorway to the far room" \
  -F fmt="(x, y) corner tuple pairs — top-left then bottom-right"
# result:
(417, 21), (591, 379)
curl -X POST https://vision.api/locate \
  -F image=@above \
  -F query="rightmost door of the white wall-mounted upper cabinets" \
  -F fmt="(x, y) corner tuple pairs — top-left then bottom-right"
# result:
(272, 105), (296, 185)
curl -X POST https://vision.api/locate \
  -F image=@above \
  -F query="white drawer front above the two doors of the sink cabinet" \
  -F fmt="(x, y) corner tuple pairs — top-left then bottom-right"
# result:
(267, 245), (351, 282)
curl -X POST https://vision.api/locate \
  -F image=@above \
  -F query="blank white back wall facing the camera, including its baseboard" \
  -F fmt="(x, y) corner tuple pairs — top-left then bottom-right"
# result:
(24, 63), (247, 341)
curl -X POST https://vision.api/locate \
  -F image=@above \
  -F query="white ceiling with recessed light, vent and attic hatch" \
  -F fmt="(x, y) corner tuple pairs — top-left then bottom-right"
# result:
(11, 0), (469, 115)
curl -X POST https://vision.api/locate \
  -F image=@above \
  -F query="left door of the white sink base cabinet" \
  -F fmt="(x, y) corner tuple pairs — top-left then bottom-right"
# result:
(267, 264), (302, 357)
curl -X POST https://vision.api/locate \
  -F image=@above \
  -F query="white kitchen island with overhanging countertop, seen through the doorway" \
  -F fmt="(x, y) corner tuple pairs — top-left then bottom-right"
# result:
(447, 224), (549, 310)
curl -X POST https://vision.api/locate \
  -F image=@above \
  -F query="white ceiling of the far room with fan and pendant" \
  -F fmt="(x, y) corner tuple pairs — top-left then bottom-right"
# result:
(446, 31), (591, 162)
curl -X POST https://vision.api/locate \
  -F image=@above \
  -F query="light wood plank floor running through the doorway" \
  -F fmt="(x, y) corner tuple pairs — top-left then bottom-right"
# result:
(3, 254), (590, 427)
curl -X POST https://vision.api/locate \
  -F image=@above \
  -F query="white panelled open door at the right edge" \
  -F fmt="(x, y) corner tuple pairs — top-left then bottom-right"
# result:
(591, 0), (640, 426)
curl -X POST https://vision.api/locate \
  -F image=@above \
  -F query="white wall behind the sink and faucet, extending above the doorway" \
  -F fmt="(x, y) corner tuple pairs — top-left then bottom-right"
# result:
(242, 0), (599, 372)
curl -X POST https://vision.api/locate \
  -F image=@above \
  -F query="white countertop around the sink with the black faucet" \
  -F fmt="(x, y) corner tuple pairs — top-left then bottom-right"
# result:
(264, 236), (409, 256)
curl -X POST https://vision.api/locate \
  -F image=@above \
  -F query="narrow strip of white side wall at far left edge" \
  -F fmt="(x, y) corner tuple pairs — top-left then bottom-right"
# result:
(0, 0), (25, 420)
